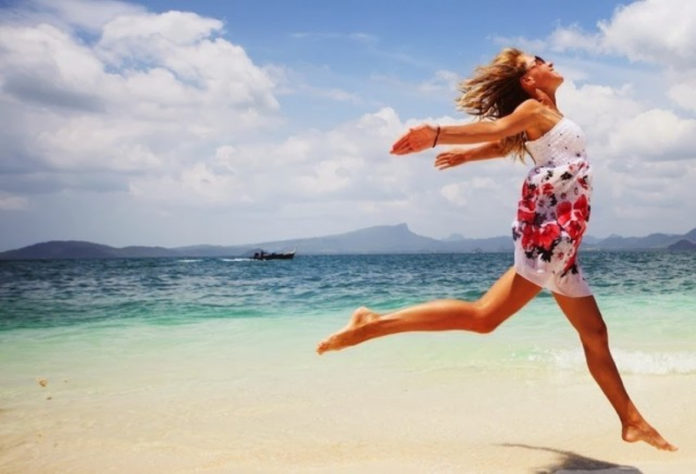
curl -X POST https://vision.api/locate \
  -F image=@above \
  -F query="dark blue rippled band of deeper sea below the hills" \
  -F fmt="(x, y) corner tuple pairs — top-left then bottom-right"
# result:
(0, 252), (696, 331)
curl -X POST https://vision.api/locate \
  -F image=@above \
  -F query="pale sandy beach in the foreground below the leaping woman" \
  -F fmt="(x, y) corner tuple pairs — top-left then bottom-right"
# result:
(0, 323), (696, 474)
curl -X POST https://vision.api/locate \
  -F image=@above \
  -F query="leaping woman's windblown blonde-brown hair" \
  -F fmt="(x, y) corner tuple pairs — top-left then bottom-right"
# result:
(457, 48), (530, 161)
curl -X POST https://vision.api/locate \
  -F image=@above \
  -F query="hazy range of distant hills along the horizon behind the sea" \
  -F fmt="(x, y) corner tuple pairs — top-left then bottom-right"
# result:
(0, 224), (696, 260)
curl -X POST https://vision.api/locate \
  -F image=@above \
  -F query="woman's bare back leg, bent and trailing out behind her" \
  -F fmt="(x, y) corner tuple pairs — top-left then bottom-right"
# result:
(317, 268), (541, 354)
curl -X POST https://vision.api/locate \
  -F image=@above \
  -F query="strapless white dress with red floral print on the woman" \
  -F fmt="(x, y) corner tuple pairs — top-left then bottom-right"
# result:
(512, 117), (592, 297)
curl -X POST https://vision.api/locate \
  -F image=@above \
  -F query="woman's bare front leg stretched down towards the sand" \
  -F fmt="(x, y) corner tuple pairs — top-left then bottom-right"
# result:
(553, 293), (677, 451)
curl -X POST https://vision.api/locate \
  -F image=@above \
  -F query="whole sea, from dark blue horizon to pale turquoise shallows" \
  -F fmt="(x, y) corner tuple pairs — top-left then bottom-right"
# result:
(0, 252), (696, 378)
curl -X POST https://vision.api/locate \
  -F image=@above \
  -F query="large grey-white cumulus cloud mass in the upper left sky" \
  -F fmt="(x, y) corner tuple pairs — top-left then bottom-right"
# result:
(0, 0), (279, 195)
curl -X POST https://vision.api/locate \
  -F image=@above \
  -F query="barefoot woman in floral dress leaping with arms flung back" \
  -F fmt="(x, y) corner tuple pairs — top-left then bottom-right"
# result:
(317, 49), (677, 451)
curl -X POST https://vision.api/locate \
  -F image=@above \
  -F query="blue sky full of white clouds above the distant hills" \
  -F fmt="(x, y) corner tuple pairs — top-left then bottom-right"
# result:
(0, 0), (696, 250)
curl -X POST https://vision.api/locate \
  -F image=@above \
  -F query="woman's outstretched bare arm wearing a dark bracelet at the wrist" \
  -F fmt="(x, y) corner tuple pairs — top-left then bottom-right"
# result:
(391, 99), (543, 155)
